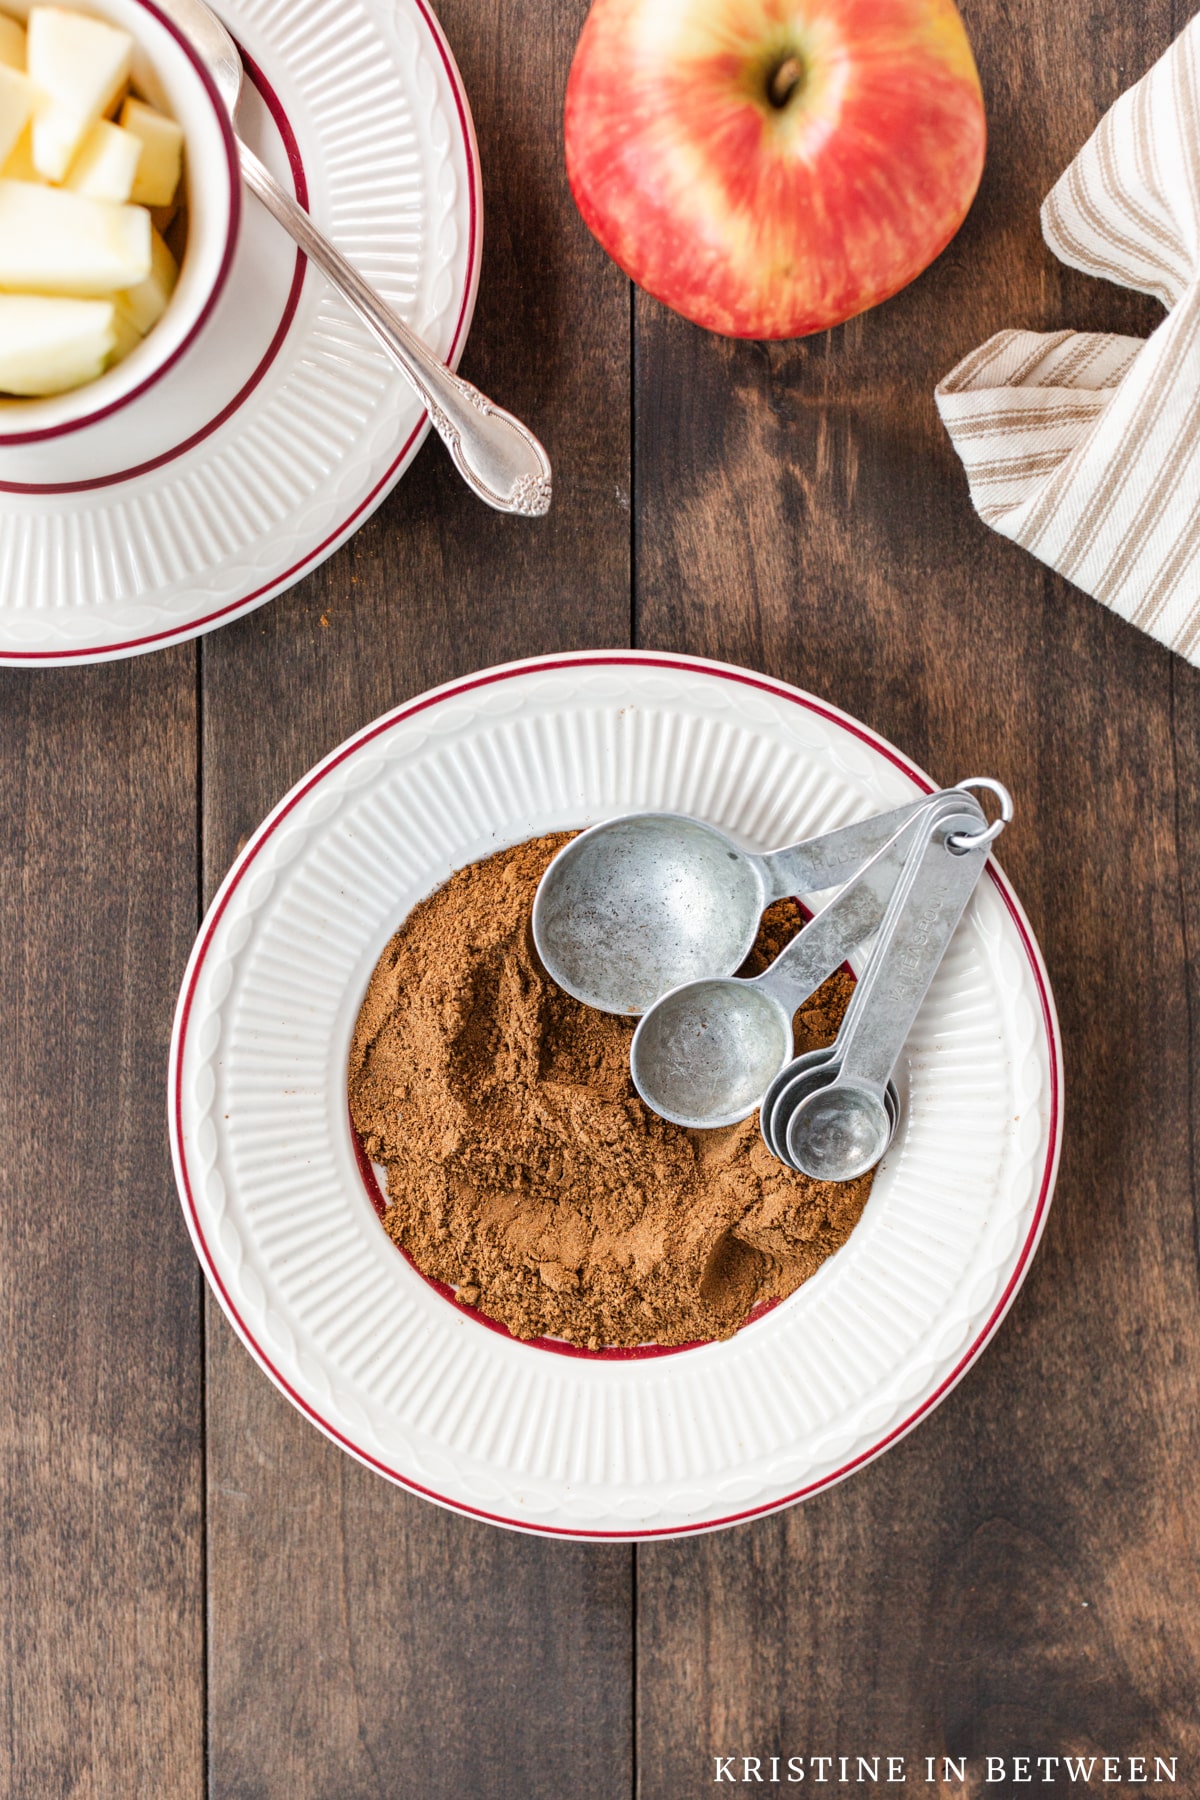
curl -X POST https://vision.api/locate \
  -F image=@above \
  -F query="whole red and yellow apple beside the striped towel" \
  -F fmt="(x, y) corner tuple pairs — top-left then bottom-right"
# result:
(565, 0), (986, 338)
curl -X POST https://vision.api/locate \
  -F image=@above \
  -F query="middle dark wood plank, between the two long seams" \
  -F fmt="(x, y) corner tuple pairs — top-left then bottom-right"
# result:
(203, 0), (631, 1800)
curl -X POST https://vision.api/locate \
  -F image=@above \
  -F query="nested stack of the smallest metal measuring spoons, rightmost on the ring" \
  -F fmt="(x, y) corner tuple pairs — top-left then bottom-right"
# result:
(759, 779), (1013, 1181)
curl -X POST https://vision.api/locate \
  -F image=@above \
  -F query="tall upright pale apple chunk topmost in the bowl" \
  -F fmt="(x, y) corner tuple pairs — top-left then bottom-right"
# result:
(27, 5), (133, 182)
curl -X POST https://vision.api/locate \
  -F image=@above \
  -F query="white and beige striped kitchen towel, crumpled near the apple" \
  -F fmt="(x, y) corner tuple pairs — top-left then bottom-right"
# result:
(937, 14), (1200, 664)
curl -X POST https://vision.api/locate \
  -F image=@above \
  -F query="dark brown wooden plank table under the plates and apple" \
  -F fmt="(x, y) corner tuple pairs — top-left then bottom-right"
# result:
(0, 0), (1200, 1800)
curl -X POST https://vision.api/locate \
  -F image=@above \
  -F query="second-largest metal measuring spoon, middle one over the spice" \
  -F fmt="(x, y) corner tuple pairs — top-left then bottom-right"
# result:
(630, 788), (986, 1129)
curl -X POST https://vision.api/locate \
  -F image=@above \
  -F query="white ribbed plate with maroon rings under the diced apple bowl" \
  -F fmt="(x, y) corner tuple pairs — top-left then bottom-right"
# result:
(0, 0), (482, 666)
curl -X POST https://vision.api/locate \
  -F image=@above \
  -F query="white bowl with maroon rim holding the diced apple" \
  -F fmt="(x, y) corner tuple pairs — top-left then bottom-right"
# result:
(0, 0), (241, 446)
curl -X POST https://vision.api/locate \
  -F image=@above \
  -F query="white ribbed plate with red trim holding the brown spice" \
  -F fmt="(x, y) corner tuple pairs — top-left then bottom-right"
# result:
(169, 652), (1061, 1539)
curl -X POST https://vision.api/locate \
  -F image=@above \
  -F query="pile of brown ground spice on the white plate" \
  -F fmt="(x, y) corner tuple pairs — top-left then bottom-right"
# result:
(349, 833), (871, 1348)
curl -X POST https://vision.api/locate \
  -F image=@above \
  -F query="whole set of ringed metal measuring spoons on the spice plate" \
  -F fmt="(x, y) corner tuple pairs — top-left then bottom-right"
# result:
(533, 778), (1013, 1181)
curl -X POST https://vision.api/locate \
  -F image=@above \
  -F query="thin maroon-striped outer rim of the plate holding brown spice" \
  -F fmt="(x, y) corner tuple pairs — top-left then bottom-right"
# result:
(167, 650), (1063, 1543)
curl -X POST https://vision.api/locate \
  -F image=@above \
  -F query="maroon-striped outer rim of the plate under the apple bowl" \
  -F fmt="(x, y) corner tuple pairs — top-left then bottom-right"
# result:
(0, 0), (480, 668)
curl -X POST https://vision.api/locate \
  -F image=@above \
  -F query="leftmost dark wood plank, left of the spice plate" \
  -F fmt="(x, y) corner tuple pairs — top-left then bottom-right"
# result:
(0, 646), (203, 1800)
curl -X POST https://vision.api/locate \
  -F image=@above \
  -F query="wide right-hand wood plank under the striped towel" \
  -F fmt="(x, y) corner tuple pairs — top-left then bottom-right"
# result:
(635, 0), (1200, 1800)
